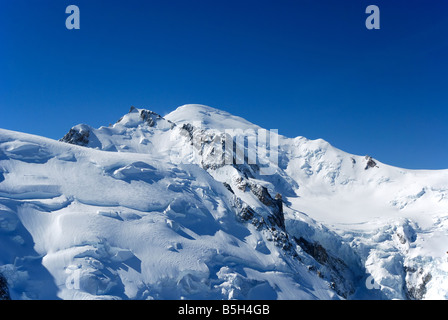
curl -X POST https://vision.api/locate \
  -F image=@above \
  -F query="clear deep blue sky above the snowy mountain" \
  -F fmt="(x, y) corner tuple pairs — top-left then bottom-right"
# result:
(0, 0), (448, 169)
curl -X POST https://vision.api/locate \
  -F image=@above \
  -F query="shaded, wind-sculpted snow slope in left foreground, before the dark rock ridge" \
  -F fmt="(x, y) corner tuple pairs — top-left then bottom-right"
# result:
(0, 126), (336, 299)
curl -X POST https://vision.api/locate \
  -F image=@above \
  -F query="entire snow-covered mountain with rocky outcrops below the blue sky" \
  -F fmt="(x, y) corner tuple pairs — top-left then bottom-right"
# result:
(0, 105), (448, 299)
